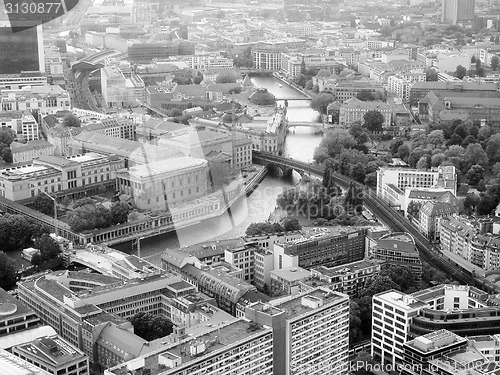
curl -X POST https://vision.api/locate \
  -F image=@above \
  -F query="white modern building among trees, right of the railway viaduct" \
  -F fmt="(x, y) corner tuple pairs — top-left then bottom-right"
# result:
(377, 166), (457, 209)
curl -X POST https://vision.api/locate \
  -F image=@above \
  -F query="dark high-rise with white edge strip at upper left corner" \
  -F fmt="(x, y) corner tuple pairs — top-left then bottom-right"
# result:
(0, 19), (45, 74)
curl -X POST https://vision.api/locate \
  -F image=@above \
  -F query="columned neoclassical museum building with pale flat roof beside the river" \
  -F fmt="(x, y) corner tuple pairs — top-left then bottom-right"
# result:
(116, 157), (208, 211)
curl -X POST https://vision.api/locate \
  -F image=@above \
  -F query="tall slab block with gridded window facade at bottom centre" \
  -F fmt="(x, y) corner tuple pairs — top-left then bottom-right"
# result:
(245, 288), (349, 375)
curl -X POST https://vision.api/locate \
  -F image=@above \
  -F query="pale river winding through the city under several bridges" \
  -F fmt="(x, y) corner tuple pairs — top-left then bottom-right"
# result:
(114, 76), (322, 264)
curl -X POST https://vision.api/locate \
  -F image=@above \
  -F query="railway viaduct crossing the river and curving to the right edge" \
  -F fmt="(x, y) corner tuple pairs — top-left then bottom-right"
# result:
(253, 151), (500, 293)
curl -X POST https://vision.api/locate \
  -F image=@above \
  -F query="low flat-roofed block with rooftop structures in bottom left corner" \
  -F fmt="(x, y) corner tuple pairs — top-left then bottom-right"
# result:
(11, 335), (89, 375)
